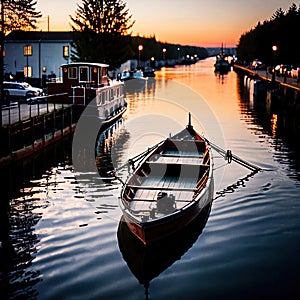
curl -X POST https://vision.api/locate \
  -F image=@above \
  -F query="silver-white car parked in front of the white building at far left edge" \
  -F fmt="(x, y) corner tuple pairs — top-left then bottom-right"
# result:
(3, 81), (43, 101)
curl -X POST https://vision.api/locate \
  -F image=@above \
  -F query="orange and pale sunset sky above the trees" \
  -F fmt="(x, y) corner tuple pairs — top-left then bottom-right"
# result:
(37, 0), (299, 47)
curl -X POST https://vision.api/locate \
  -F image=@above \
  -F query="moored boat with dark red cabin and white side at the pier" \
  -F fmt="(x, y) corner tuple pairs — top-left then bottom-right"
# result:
(48, 62), (127, 129)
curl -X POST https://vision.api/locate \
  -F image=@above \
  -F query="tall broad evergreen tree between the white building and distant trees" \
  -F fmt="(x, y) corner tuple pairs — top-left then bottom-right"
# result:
(71, 0), (134, 68)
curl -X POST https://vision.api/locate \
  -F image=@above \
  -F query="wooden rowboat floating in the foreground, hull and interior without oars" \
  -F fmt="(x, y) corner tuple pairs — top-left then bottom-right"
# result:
(120, 116), (214, 244)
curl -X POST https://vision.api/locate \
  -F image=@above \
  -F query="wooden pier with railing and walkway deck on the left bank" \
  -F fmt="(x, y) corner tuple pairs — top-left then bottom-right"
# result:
(0, 103), (83, 166)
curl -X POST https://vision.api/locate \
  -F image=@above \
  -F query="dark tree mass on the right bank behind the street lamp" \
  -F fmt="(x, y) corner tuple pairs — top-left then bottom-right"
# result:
(237, 3), (300, 65)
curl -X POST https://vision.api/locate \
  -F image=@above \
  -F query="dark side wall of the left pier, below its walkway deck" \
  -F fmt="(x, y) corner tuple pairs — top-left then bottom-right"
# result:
(0, 105), (83, 167)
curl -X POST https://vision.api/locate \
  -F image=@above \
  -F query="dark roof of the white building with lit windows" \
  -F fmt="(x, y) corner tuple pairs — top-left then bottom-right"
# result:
(5, 30), (73, 42)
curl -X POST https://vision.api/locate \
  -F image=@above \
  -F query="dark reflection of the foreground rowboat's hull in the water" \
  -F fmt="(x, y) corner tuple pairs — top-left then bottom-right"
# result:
(117, 204), (211, 299)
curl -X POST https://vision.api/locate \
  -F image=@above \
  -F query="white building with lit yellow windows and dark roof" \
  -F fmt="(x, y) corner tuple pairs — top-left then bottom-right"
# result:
(4, 30), (73, 79)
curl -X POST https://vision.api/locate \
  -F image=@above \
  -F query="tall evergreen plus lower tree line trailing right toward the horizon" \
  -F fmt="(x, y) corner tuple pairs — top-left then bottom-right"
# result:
(71, 0), (207, 68)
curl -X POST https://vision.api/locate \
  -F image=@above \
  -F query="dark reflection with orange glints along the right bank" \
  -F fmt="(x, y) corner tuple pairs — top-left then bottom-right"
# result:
(237, 77), (300, 181)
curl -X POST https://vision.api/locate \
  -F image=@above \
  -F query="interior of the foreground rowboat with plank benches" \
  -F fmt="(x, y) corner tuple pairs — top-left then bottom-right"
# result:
(124, 139), (210, 219)
